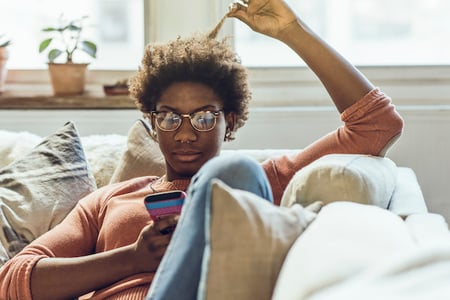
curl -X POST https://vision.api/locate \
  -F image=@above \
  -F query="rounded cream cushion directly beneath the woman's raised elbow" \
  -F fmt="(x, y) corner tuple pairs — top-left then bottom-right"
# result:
(280, 154), (397, 208)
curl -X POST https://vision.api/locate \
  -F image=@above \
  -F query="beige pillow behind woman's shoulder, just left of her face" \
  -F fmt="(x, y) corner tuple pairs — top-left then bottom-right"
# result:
(110, 119), (166, 183)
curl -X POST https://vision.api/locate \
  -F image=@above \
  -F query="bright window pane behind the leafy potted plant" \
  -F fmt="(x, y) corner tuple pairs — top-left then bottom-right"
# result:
(0, 0), (144, 70)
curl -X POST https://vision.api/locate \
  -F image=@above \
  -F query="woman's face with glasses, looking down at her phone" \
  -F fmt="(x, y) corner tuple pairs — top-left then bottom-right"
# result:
(152, 82), (234, 180)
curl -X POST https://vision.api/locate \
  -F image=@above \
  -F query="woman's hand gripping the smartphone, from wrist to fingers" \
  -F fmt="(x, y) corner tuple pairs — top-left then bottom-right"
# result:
(134, 215), (179, 272)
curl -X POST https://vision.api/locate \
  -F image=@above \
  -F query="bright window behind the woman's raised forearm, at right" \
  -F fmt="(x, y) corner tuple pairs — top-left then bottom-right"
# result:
(234, 0), (450, 66)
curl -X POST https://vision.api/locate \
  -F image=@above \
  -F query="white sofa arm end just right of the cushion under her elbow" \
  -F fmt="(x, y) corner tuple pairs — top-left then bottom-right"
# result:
(388, 167), (428, 217)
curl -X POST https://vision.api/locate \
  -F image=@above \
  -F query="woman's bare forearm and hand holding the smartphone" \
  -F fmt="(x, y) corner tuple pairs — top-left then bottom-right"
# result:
(31, 215), (179, 300)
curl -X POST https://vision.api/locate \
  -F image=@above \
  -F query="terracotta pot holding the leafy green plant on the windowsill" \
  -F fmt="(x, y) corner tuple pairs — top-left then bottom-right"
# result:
(48, 63), (88, 96)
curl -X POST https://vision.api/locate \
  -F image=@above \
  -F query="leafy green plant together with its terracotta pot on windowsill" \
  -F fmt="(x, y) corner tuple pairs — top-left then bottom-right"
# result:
(39, 16), (97, 96)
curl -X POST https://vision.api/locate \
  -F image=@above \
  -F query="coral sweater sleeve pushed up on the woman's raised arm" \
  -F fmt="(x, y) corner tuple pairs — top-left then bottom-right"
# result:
(263, 88), (403, 205)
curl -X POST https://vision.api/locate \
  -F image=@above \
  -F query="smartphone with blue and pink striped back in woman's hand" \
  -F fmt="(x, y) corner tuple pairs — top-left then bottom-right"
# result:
(144, 190), (186, 221)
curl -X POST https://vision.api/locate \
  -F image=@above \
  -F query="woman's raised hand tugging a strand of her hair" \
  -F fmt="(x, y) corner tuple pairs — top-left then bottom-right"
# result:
(228, 0), (297, 39)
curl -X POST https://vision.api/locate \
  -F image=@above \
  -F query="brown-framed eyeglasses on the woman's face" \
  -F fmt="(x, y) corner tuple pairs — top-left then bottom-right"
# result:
(151, 110), (223, 131)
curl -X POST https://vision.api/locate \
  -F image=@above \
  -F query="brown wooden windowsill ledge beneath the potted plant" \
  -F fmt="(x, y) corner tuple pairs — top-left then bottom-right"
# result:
(0, 84), (136, 109)
